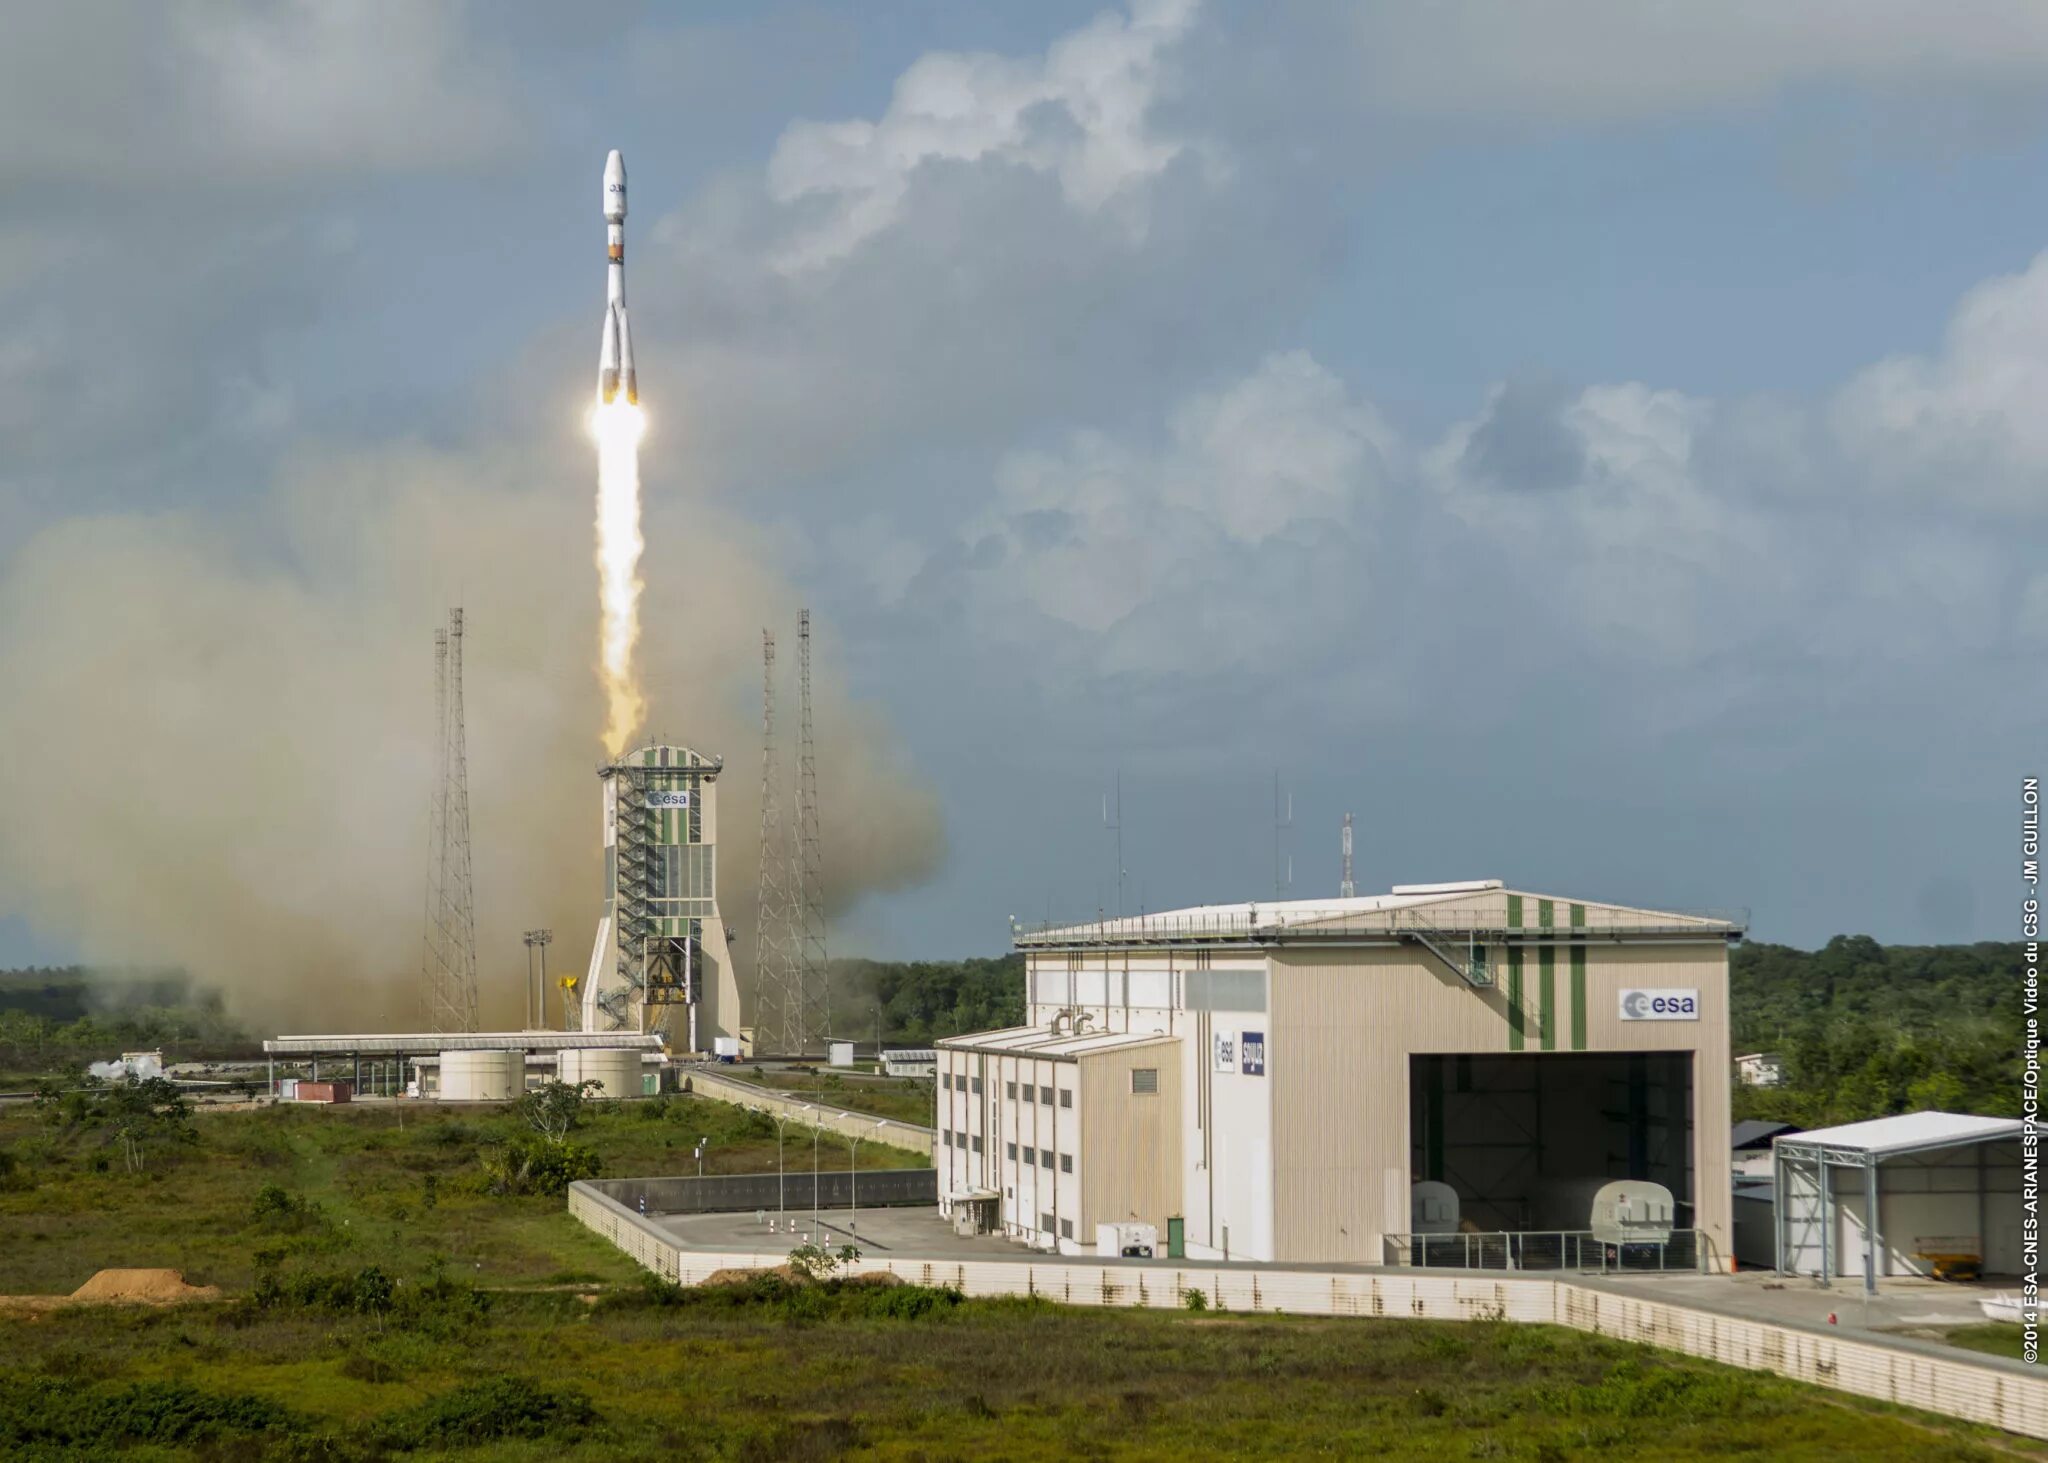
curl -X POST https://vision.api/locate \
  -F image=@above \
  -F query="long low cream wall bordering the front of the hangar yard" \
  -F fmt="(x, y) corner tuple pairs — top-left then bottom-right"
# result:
(569, 1182), (2048, 1438)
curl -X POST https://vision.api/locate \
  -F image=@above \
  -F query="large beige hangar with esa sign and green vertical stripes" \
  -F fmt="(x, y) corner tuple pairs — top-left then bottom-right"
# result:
(936, 879), (1743, 1270)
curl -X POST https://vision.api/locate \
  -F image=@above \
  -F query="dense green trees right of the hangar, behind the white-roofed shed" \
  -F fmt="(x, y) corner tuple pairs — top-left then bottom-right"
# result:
(1729, 934), (2021, 1127)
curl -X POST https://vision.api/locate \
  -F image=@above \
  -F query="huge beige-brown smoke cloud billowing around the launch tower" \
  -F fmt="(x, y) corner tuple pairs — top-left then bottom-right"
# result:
(0, 422), (944, 1029)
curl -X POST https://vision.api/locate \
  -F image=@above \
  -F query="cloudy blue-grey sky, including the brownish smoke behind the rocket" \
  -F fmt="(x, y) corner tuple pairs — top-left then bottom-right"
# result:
(0, 0), (2048, 991)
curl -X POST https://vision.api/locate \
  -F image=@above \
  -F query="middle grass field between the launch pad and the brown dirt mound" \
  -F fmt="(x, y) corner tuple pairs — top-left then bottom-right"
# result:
(0, 1084), (928, 1295)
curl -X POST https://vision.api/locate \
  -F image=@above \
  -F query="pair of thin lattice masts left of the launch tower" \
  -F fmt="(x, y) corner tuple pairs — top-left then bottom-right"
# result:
(422, 609), (477, 1031)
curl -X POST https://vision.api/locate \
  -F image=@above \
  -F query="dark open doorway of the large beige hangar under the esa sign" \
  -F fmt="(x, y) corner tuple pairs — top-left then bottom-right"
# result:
(1409, 1051), (1694, 1234)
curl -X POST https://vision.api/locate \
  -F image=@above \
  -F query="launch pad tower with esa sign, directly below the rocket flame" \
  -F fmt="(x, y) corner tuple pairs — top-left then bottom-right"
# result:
(582, 746), (739, 1051)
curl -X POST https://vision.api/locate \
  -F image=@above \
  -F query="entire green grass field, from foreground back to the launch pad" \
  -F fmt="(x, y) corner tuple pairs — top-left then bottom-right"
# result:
(0, 1098), (2013, 1463)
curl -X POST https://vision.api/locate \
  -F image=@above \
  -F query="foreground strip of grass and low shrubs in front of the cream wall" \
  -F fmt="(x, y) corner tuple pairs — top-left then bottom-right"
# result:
(0, 1274), (2007, 1461)
